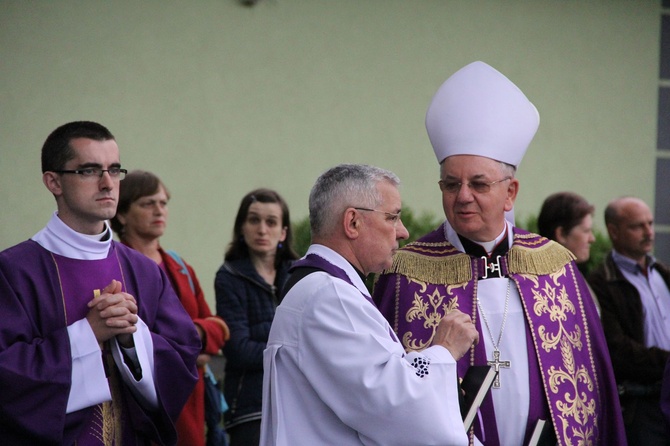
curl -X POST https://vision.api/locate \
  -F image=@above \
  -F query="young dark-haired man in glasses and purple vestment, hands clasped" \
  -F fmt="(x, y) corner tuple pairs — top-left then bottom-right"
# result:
(0, 121), (200, 445)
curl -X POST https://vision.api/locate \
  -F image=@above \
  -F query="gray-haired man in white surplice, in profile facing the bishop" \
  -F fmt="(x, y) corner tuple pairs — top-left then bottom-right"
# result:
(261, 165), (478, 446)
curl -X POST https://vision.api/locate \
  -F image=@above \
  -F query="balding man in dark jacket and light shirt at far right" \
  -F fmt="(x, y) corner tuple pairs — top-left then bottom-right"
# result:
(589, 197), (670, 446)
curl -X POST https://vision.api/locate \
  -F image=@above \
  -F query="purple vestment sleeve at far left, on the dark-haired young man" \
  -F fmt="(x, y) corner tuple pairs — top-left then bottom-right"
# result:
(0, 241), (100, 445)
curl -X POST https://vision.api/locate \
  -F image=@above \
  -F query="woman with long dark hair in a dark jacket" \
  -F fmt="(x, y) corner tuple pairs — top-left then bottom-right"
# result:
(214, 189), (298, 446)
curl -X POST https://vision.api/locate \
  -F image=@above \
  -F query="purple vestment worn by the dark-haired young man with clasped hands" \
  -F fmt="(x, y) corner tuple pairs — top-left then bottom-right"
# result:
(0, 240), (200, 445)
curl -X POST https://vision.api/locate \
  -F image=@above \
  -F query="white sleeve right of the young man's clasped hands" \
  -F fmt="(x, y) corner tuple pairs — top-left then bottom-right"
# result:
(112, 318), (158, 409)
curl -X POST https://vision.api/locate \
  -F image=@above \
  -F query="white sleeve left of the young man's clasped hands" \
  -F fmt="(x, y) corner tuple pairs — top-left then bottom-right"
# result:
(66, 319), (112, 413)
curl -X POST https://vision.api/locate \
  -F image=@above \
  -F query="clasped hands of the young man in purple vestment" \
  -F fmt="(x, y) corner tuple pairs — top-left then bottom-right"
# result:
(86, 280), (138, 346)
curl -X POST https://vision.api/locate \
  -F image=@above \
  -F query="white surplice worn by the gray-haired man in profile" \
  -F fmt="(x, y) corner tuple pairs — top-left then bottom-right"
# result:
(261, 245), (468, 446)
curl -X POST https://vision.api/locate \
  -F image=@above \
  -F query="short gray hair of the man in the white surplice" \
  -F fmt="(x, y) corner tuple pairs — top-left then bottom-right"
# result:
(309, 164), (400, 237)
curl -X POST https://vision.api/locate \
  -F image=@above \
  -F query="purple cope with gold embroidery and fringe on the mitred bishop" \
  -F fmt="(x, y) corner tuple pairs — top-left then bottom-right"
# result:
(373, 227), (626, 446)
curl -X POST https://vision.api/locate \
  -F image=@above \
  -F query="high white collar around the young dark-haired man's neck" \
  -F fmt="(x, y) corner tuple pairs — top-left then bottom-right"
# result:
(32, 212), (112, 260)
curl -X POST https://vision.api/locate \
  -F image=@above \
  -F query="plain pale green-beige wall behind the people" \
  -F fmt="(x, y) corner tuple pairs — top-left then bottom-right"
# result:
(0, 0), (661, 310)
